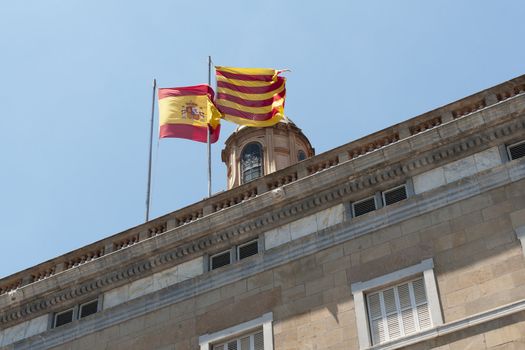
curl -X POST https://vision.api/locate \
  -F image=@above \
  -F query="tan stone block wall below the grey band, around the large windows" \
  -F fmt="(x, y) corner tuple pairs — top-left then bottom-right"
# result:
(40, 180), (525, 350)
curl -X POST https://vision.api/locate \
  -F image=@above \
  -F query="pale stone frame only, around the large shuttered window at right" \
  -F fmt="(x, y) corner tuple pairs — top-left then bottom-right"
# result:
(351, 259), (443, 349)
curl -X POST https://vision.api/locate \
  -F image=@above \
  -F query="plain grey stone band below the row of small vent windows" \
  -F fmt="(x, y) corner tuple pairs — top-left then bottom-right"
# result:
(7, 159), (525, 349)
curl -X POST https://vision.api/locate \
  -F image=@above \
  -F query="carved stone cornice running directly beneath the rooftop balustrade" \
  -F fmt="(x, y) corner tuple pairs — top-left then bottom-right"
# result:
(0, 80), (525, 328)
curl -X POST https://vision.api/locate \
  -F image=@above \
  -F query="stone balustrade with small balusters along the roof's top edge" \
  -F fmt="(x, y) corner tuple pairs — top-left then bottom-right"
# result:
(0, 76), (525, 295)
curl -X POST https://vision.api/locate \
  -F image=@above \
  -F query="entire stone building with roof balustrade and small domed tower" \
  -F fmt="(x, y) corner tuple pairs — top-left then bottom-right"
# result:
(0, 76), (525, 350)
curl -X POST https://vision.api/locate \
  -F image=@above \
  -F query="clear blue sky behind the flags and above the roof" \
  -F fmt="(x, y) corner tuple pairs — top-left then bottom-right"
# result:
(0, 0), (525, 277)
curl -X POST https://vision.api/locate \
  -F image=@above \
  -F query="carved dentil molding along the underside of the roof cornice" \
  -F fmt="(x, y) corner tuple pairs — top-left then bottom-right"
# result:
(0, 110), (525, 328)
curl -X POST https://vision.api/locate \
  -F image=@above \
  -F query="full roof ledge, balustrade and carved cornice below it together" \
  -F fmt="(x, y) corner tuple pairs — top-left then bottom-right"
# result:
(0, 76), (525, 326)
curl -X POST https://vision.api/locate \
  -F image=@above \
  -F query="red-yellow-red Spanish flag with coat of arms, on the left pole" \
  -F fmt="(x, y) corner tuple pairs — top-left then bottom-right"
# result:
(159, 84), (221, 143)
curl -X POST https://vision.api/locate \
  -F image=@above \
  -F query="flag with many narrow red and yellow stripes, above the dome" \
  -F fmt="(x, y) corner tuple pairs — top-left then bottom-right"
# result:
(215, 66), (286, 127)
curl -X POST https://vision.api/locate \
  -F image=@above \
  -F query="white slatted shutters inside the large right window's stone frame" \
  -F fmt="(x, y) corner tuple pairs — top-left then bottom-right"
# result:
(366, 278), (432, 345)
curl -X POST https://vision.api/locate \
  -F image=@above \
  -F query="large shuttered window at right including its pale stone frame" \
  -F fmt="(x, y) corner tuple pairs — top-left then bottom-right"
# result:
(351, 259), (443, 349)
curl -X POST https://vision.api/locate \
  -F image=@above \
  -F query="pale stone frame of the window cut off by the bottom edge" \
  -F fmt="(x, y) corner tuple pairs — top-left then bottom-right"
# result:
(199, 312), (273, 350)
